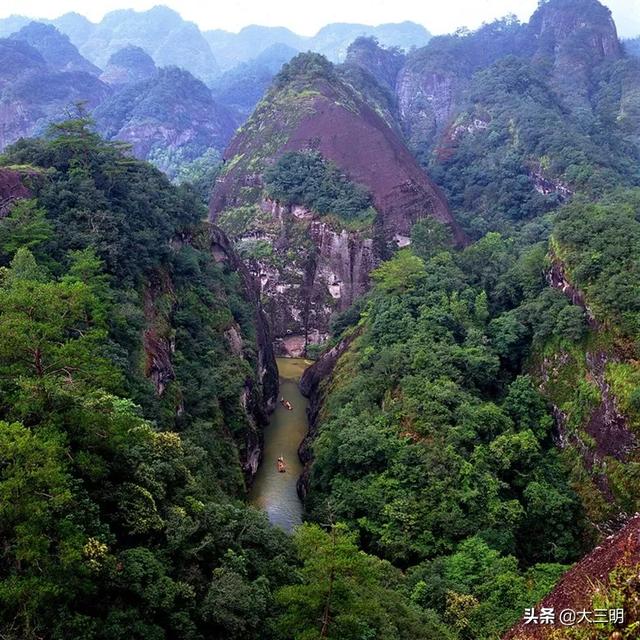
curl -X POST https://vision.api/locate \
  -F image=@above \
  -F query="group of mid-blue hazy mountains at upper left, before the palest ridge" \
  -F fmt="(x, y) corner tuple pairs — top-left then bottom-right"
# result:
(0, 22), (237, 179)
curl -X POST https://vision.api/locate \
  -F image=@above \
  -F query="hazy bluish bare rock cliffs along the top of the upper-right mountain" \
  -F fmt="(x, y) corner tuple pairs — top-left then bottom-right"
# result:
(396, 0), (622, 158)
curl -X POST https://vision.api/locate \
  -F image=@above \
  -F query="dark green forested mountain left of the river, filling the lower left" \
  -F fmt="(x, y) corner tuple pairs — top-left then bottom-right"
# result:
(0, 120), (295, 640)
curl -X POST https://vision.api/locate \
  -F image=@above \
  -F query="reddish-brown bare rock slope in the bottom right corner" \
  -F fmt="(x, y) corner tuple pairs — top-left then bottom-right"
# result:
(503, 515), (640, 640)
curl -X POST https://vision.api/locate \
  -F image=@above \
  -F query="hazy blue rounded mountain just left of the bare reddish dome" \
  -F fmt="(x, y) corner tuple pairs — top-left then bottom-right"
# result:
(93, 66), (235, 177)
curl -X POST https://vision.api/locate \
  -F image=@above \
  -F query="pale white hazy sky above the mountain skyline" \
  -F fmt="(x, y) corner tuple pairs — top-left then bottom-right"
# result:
(0, 0), (640, 37)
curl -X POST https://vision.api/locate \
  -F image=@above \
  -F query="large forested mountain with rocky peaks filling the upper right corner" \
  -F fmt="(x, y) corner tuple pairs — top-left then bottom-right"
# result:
(396, 0), (640, 234)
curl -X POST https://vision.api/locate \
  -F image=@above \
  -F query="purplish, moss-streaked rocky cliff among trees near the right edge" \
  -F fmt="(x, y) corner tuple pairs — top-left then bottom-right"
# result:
(537, 252), (640, 534)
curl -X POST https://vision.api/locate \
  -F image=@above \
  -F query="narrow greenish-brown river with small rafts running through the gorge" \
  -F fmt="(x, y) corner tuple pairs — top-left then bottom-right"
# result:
(249, 358), (311, 531)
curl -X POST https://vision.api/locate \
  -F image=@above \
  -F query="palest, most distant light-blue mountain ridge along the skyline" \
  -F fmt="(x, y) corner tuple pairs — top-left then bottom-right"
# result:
(0, 5), (431, 79)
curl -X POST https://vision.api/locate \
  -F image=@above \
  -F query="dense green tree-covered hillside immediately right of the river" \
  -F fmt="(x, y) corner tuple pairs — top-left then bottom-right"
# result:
(307, 236), (583, 640)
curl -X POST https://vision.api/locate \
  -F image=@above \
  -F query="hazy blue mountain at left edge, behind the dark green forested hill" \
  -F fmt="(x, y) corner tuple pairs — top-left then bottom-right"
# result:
(0, 37), (109, 148)
